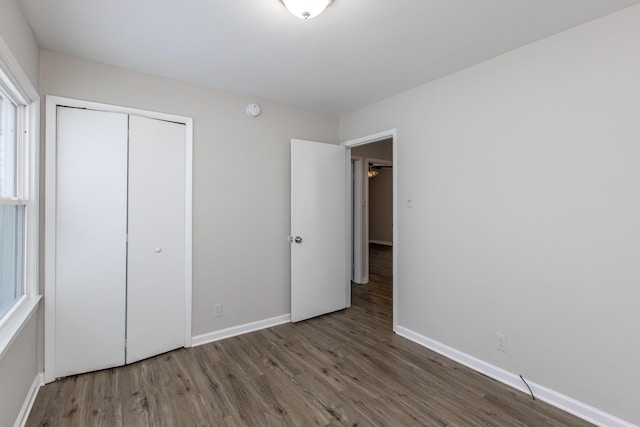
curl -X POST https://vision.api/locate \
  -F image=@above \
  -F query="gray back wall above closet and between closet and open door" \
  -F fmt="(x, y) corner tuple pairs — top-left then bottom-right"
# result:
(40, 51), (338, 336)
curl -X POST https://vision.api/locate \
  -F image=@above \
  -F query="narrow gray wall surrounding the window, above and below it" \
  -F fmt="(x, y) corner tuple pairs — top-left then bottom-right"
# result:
(0, 0), (41, 426)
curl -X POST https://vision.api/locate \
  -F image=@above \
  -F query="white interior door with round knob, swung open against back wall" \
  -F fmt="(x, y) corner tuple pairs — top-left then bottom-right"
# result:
(291, 139), (351, 322)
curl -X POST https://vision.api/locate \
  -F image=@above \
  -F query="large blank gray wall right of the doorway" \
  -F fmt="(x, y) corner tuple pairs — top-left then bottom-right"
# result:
(341, 6), (640, 424)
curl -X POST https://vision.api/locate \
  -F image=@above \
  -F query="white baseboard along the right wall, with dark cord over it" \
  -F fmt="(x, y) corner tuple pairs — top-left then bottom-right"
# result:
(396, 326), (637, 427)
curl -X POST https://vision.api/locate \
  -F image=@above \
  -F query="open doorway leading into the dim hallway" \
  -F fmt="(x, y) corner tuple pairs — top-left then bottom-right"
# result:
(343, 129), (397, 331)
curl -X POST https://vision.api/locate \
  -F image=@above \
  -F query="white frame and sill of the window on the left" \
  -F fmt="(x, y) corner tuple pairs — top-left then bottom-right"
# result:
(0, 37), (42, 359)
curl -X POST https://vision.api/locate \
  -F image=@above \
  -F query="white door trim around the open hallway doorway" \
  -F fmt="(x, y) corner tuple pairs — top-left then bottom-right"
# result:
(341, 128), (398, 332)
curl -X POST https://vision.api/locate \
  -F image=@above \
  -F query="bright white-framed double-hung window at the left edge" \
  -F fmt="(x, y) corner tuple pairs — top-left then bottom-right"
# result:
(0, 38), (40, 348)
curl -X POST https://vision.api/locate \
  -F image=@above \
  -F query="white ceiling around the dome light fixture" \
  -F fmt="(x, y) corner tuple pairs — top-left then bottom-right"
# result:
(19, 0), (640, 114)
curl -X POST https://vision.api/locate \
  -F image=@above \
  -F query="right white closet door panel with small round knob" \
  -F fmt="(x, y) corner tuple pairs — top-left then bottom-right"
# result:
(126, 116), (186, 363)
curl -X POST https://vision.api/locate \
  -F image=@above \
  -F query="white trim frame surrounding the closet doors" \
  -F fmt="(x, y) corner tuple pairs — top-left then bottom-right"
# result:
(44, 96), (193, 383)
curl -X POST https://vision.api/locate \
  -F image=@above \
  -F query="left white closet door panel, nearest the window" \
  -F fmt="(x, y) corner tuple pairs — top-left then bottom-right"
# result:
(55, 107), (128, 377)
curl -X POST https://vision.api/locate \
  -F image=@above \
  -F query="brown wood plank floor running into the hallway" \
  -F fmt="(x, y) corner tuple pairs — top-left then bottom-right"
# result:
(27, 247), (590, 427)
